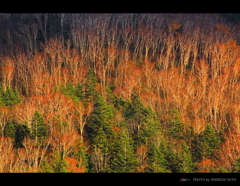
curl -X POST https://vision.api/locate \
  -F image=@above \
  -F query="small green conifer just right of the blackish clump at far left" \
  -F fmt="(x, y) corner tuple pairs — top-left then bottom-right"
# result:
(31, 111), (47, 141)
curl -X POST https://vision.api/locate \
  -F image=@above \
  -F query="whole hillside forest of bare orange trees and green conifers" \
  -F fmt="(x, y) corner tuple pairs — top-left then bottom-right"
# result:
(0, 13), (240, 173)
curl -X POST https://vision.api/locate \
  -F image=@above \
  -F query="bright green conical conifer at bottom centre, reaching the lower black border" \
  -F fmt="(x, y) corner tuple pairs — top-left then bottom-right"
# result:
(111, 128), (138, 173)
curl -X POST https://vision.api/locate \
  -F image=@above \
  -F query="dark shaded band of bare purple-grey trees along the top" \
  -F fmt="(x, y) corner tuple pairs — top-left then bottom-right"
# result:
(0, 13), (238, 56)
